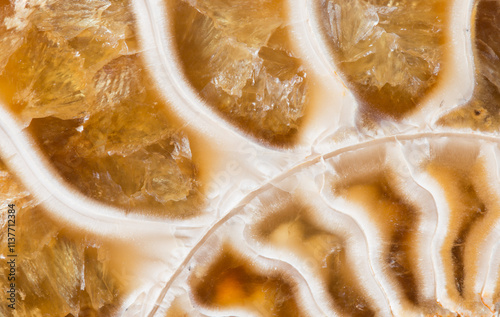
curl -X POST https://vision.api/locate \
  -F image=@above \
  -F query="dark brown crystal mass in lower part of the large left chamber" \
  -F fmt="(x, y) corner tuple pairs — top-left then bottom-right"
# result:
(29, 97), (197, 212)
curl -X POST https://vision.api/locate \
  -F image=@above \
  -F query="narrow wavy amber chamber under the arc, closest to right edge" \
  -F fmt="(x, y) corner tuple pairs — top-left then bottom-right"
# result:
(426, 142), (500, 310)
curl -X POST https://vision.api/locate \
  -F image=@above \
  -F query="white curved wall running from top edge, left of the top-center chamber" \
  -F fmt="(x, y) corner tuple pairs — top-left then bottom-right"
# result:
(132, 0), (304, 148)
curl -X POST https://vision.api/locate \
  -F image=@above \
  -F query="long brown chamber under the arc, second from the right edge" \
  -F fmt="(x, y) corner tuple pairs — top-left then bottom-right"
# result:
(328, 148), (448, 314)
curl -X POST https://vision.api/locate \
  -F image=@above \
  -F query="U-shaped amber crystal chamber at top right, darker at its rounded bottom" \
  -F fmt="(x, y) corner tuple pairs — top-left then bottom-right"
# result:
(316, 0), (450, 119)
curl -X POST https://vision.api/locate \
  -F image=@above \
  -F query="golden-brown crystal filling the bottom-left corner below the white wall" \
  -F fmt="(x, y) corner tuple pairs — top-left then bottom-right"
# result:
(0, 161), (132, 316)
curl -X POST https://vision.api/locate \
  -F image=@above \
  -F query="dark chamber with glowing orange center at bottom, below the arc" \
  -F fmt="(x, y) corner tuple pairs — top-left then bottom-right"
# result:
(189, 244), (304, 316)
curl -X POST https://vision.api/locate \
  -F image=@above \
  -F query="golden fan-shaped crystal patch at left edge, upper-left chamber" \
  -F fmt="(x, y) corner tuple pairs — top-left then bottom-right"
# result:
(0, 31), (88, 119)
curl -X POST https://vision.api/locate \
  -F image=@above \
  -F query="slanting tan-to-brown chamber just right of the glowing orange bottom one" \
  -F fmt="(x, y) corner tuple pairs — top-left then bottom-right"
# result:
(251, 194), (375, 316)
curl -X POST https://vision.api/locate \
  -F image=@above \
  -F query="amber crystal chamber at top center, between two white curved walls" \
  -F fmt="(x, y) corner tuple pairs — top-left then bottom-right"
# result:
(175, 1), (307, 144)
